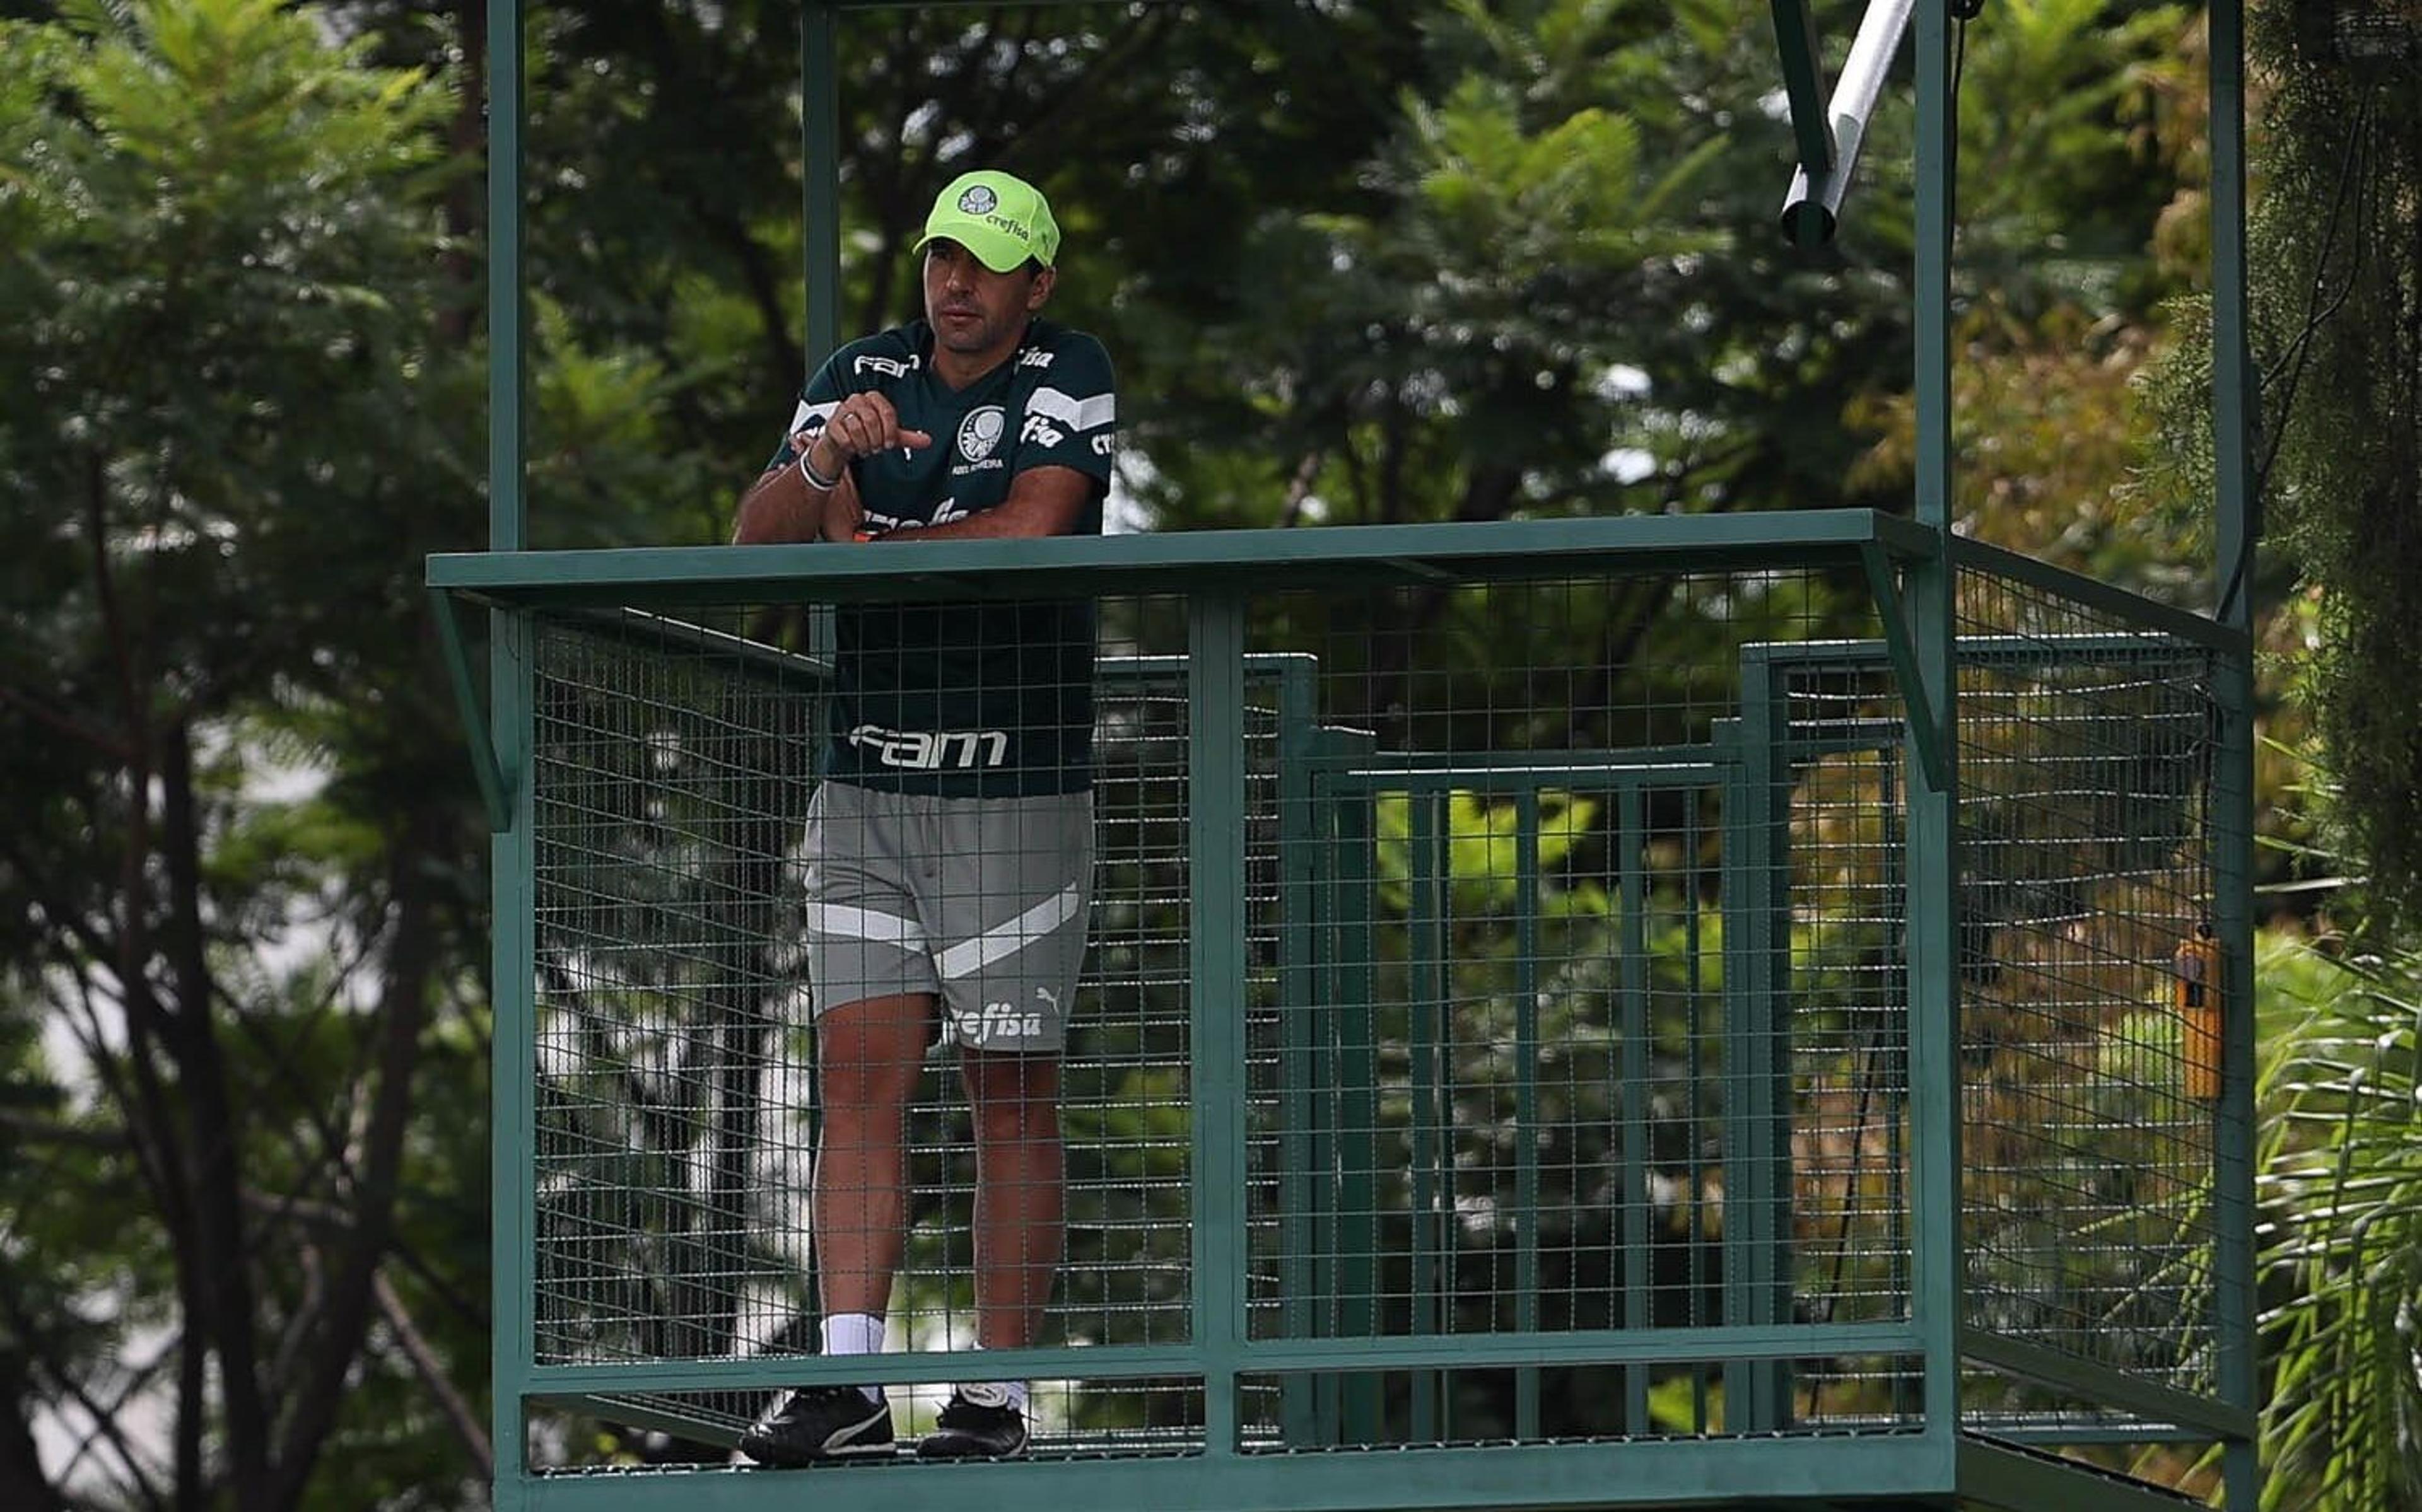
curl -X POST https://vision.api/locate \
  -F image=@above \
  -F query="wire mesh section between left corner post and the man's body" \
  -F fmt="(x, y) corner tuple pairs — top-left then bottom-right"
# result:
(530, 615), (824, 1364)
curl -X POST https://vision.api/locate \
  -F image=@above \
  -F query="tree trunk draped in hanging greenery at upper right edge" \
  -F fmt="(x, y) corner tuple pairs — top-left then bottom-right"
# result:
(2250, 3), (2422, 933)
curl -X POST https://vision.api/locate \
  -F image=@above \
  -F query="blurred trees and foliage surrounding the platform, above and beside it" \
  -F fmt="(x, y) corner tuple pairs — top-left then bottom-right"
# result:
(0, 0), (2422, 1512)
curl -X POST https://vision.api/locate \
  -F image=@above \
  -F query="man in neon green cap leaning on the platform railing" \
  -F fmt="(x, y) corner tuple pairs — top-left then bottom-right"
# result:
(734, 172), (1116, 1466)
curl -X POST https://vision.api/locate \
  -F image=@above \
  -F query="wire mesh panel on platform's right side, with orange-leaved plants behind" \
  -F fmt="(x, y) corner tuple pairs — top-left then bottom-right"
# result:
(1960, 572), (2218, 1415)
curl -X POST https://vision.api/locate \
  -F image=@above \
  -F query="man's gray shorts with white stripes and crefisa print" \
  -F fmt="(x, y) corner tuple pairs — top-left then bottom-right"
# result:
(807, 782), (1092, 1052)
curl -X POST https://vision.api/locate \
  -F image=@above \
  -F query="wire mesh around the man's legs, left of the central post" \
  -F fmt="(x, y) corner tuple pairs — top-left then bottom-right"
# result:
(533, 601), (1272, 1451)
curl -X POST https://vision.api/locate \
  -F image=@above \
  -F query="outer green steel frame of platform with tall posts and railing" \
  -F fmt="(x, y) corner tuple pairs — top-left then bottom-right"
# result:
(462, 0), (2260, 1512)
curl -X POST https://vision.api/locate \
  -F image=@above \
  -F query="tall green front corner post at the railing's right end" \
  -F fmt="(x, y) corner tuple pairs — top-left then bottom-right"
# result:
(1904, 0), (1964, 1463)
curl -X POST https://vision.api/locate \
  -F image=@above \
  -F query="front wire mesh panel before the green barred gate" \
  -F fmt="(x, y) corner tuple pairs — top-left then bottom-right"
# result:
(1230, 574), (1909, 1446)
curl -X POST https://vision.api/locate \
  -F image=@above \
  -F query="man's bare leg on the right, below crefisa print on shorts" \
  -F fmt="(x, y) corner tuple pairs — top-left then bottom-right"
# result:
(959, 1049), (1066, 1350)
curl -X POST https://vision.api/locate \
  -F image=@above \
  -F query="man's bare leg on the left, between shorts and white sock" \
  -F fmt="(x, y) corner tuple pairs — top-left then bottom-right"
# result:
(809, 994), (935, 1318)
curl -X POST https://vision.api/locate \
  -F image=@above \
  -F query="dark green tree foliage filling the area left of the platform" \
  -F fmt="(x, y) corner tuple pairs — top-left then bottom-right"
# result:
(0, 0), (484, 1512)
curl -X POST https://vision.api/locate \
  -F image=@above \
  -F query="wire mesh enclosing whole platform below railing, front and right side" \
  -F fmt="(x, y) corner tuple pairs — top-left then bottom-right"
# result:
(506, 550), (2211, 1461)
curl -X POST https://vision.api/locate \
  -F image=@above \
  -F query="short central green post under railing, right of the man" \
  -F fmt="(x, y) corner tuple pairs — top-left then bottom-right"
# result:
(1187, 594), (1248, 1461)
